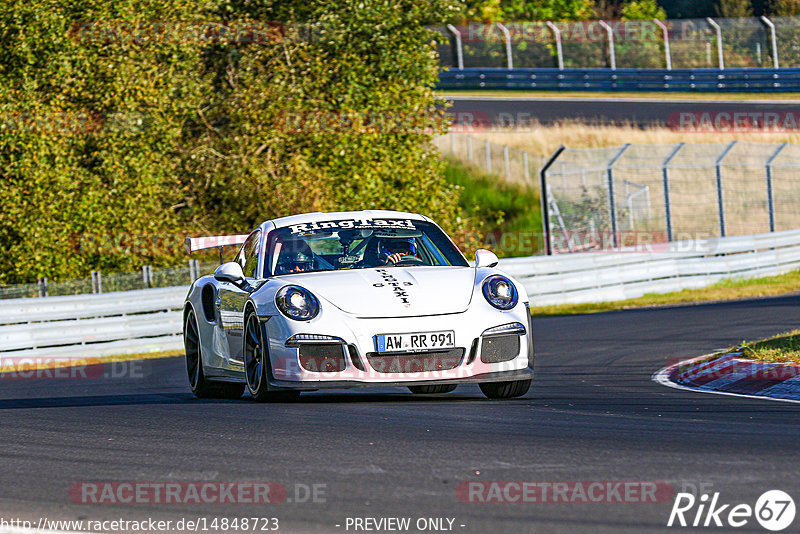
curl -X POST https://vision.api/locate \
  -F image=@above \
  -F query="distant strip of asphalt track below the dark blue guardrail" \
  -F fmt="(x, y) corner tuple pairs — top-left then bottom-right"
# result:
(446, 96), (797, 128)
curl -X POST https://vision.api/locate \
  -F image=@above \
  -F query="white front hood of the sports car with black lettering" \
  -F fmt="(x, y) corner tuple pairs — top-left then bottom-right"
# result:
(281, 266), (475, 317)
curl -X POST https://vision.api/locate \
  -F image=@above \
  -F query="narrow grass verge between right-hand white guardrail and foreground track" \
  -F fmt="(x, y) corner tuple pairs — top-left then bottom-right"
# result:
(531, 271), (800, 317)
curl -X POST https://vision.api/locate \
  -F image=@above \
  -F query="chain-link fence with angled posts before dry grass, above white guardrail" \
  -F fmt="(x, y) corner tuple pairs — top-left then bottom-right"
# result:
(532, 141), (800, 252)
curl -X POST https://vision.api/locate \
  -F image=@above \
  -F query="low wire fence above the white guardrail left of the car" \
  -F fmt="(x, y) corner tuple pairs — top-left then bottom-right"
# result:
(0, 260), (219, 299)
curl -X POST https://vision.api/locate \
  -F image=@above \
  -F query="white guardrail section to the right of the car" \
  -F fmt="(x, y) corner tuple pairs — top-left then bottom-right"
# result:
(499, 230), (800, 306)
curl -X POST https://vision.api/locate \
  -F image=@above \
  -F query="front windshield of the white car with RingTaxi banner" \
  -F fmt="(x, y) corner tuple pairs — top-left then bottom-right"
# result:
(265, 219), (469, 276)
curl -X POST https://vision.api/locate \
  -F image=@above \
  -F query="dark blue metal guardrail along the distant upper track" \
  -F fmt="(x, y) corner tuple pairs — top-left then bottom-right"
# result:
(437, 67), (800, 93)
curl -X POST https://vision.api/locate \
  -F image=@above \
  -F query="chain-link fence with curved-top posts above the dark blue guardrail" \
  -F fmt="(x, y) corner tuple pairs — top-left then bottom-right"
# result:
(431, 17), (800, 69)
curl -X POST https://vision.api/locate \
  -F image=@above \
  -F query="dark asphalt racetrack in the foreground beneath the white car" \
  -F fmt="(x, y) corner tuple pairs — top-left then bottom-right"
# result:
(0, 296), (800, 534)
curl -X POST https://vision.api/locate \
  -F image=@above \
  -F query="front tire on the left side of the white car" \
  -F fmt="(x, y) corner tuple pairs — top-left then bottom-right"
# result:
(242, 309), (300, 402)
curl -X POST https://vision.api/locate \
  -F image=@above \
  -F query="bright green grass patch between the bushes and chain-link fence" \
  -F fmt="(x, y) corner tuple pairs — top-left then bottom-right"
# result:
(445, 159), (542, 257)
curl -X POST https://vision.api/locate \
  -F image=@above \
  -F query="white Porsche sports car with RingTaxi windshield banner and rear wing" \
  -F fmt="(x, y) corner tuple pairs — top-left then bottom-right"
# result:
(183, 211), (533, 401)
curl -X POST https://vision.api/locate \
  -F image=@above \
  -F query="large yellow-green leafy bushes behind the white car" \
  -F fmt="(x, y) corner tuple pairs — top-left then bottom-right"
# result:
(0, 0), (463, 283)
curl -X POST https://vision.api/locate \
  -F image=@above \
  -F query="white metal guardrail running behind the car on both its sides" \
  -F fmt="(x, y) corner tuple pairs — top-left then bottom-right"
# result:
(0, 230), (800, 362)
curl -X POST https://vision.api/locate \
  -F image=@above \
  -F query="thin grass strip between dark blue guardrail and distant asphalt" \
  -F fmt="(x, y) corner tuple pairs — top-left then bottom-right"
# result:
(436, 89), (800, 102)
